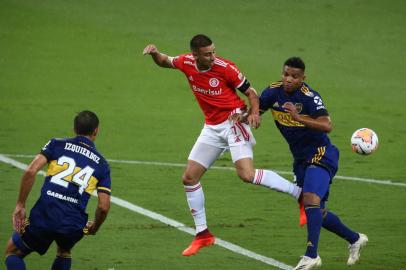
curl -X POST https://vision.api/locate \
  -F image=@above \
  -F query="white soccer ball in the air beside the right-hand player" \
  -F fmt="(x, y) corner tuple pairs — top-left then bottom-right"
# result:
(351, 128), (378, 155)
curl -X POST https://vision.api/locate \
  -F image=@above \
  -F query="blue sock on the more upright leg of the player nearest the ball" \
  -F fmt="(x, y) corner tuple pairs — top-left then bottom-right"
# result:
(305, 205), (323, 258)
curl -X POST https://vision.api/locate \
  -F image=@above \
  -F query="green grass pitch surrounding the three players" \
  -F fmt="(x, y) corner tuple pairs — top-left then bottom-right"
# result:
(0, 0), (406, 270)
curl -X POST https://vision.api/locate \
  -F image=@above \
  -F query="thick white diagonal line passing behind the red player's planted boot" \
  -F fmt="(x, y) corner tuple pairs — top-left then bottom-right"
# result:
(0, 154), (293, 270)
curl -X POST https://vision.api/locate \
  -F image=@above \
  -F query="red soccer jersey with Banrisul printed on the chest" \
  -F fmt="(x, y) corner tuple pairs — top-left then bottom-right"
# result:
(172, 54), (246, 125)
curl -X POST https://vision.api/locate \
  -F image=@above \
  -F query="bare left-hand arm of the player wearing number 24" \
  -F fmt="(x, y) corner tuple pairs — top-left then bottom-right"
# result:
(13, 154), (47, 233)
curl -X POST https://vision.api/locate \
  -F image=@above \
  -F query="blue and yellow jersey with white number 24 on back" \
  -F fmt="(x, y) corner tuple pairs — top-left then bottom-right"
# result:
(30, 136), (111, 233)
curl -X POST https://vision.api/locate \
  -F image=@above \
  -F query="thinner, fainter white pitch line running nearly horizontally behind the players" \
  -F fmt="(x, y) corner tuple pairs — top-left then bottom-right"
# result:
(0, 154), (406, 187)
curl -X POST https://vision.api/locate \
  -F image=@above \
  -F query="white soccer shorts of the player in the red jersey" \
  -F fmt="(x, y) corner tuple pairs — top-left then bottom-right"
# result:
(188, 120), (256, 169)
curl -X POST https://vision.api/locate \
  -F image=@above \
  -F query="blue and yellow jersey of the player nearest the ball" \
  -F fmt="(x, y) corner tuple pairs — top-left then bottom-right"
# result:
(259, 82), (331, 163)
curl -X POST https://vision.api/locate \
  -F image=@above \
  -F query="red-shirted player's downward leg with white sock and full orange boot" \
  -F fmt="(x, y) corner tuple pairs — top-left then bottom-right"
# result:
(182, 142), (223, 256)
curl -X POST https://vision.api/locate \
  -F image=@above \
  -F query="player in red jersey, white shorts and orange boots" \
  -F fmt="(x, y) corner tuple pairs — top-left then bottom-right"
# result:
(143, 34), (301, 256)
